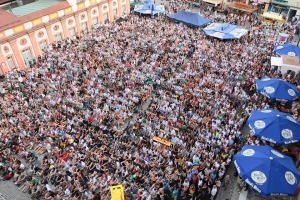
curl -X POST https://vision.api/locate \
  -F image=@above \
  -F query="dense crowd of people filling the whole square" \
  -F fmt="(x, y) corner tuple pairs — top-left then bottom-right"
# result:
(0, 1), (300, 200)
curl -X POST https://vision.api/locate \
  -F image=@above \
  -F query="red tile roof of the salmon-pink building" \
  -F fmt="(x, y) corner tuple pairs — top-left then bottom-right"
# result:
(0, 1), (70, 31)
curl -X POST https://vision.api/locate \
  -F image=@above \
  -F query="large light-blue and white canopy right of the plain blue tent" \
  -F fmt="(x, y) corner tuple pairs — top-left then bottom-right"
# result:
(203, 23), (248, 39)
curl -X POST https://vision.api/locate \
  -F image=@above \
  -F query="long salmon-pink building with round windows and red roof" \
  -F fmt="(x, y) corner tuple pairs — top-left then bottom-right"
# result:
(0, 0), (130, 74)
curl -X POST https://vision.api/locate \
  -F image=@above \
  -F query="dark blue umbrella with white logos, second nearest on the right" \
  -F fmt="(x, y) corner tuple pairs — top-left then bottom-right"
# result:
(247, 108), (300, 144)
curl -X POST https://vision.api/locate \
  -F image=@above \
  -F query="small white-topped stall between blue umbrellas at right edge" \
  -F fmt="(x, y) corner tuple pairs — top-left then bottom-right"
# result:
(271, 55), (300, 74)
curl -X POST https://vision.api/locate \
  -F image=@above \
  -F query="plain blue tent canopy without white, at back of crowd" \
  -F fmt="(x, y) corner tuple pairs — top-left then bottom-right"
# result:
(168, 10), (211, 27)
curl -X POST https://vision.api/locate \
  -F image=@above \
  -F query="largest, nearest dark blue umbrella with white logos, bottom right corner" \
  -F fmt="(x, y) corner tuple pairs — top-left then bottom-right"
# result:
(233, 145), (300, 196)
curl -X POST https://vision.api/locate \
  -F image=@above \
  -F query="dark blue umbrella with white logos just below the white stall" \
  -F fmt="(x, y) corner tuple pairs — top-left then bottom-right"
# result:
(256, 78), (300, 102)
